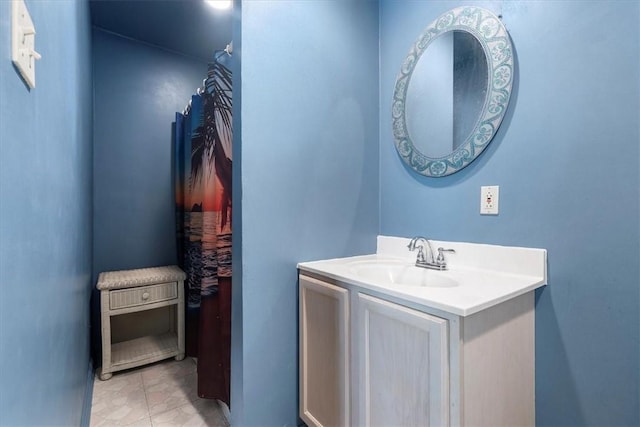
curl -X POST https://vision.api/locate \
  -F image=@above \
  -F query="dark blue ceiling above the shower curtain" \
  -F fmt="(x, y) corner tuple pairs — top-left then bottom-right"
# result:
(90, 0), (233, 60)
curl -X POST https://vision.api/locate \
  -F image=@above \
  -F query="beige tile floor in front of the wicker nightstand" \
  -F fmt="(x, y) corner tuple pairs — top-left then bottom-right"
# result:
(90, 358), (229, 427)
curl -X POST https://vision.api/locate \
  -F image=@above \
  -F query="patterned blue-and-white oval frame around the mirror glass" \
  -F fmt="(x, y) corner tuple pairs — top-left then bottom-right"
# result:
(391, 6), (514, 177)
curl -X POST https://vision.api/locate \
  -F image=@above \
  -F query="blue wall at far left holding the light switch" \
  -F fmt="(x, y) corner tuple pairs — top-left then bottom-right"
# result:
(0, 1), (92, 425)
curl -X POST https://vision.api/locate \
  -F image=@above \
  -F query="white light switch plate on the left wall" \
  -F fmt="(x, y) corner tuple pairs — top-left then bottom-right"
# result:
(11, 0), (40, 89)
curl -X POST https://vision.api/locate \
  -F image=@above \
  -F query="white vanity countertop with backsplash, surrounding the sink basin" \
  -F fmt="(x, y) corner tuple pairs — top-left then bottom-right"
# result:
(298, 236), (547, 316)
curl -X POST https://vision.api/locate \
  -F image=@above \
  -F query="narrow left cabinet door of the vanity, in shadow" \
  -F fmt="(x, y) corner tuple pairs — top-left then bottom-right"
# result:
(300, 276), (349, 426)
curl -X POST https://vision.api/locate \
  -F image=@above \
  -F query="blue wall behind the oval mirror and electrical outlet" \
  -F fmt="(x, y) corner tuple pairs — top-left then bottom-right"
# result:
(380, 1), (640, 426)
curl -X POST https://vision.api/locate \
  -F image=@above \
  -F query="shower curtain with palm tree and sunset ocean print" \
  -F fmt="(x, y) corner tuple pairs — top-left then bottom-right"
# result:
(174, 51), (232, 405)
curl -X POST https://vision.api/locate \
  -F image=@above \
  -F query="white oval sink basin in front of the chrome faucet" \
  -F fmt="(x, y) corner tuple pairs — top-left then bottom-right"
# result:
(347, 260), (459, 288)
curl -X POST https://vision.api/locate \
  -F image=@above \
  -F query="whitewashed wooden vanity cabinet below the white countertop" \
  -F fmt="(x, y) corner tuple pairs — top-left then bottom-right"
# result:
(299, 271), (535, 427)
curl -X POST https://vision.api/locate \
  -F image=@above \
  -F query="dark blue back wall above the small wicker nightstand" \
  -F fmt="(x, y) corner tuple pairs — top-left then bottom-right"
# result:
(93, 29), (207, 276)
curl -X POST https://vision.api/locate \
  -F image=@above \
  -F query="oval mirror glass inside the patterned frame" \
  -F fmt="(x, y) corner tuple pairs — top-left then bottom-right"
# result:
(405, 31), (488, 158)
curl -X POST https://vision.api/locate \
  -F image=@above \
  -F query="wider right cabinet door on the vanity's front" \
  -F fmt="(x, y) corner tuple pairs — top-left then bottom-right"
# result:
(357, 294), (449, 427)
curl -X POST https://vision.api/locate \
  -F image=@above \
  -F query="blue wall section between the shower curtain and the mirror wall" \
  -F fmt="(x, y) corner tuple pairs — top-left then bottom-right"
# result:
(236, 1), (378, 426)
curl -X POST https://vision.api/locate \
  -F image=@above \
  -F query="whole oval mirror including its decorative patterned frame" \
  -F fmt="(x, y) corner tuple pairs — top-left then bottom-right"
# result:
(392, 7), (514, 177)
